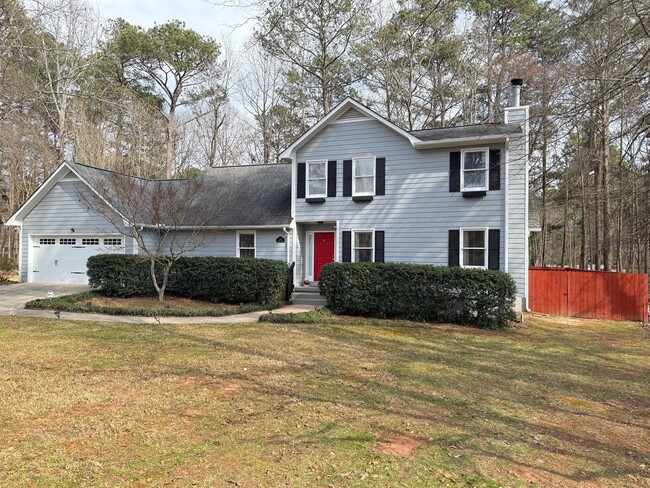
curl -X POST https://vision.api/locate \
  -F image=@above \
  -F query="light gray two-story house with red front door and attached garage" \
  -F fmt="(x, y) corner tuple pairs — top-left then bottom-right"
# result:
(8, 87), (528, 310)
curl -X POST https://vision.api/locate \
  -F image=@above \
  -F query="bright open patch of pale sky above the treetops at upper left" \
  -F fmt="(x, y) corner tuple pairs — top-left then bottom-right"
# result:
(98, 0), (253, 47)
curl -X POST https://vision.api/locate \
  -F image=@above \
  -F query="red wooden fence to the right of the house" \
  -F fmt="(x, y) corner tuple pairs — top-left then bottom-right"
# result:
(528, 267), (648, 322)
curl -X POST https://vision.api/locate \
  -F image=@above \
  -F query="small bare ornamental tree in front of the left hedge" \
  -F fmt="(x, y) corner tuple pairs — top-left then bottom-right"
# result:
(77, 172), (228, 302)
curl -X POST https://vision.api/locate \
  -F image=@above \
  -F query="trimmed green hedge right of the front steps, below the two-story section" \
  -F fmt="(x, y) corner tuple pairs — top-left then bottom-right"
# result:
(319, 263), (516, 328)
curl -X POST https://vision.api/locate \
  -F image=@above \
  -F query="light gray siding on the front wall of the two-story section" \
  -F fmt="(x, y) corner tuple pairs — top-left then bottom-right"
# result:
(294, 120), (505, 284)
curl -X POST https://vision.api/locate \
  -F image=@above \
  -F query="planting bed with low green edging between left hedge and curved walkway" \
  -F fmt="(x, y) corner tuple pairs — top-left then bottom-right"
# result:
(25, 291), (280, 317)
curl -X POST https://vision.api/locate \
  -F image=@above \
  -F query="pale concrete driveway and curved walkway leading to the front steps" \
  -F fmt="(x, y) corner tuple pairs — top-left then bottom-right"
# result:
(0, 283), (314, 324)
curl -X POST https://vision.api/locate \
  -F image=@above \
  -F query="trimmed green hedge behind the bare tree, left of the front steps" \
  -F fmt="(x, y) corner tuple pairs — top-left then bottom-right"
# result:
(88, 254), (288, 303)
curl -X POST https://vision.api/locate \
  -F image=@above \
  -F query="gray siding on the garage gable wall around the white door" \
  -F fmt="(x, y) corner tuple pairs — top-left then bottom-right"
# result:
(20, 179), (124, 282)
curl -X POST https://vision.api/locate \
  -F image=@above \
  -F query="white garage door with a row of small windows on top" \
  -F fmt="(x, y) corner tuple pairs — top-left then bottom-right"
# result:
(31, 235), (124, 284)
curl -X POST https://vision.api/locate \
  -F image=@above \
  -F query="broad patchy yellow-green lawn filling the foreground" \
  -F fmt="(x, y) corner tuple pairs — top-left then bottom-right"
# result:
(0, 314), (650, 487)
